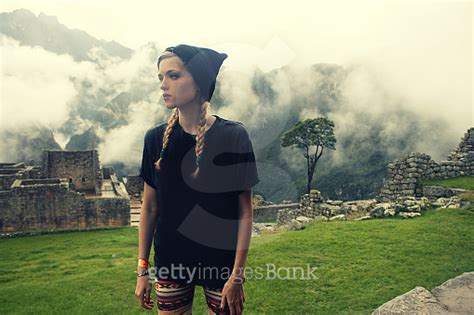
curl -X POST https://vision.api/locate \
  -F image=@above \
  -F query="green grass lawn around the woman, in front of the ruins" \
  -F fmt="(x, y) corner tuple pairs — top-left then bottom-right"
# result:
(0, 177), (474, 314)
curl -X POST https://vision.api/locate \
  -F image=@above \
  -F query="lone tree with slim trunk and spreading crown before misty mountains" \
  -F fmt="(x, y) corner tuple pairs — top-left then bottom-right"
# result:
(281, 117), (336, 194)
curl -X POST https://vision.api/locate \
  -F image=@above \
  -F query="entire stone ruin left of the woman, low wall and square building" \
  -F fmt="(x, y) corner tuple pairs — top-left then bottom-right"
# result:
(0, 150), (130, 233)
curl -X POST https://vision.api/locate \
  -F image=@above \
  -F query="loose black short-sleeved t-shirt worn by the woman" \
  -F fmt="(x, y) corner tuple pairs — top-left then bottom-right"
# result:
(140, 115), (259, 287)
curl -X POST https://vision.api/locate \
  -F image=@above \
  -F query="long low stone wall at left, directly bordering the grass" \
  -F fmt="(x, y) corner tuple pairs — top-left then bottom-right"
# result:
(0, 178), (130, 233)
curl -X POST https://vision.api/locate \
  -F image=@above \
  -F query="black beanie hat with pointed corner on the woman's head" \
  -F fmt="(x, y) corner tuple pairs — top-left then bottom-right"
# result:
(158, 44), (228, 101)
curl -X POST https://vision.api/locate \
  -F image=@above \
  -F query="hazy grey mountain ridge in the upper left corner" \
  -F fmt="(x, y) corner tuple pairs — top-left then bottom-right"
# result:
(0, 9), (133, 61)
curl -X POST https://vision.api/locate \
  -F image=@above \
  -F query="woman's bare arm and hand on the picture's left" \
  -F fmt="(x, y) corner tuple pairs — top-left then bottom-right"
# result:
(135, 182), (158, 309)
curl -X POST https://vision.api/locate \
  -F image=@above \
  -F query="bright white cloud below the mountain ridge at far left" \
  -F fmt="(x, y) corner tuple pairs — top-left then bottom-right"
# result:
(0, 34), (92, 130)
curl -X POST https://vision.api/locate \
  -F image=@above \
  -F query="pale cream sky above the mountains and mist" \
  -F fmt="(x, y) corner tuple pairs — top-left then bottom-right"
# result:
(0, 0), (472, 63)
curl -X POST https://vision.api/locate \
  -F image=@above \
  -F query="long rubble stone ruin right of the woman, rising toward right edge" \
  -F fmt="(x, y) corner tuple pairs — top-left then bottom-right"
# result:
(255, 128), (474, 234)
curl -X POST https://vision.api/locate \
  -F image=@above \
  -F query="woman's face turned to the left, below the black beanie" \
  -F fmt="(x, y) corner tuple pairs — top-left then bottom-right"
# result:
(158, 56), (198, 109)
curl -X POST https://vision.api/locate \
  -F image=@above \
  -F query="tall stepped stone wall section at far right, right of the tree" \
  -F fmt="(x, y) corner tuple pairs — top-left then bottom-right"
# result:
(377, 128), (474, 201)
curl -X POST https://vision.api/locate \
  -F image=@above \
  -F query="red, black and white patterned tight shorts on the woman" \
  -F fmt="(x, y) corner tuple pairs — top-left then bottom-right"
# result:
(155, 279), (230, 315)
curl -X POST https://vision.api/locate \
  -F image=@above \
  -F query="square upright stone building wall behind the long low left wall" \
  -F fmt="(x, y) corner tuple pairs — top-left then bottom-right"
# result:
(42, 150), (102, 193)
